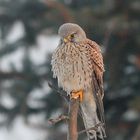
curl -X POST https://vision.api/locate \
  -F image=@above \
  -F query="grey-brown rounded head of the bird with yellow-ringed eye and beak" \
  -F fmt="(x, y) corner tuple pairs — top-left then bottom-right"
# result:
(58, 23), (86, 43)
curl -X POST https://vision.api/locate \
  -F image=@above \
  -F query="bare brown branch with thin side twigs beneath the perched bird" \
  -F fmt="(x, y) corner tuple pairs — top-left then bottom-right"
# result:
(48, 82), (104, 140)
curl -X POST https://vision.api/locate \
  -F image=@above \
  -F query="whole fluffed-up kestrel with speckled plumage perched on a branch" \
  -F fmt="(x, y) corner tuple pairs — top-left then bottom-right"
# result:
(51, 23), (106, 140)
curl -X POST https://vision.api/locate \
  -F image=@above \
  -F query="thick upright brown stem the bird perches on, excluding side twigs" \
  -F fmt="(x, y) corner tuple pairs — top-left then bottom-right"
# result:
(67, 99), (79, 140)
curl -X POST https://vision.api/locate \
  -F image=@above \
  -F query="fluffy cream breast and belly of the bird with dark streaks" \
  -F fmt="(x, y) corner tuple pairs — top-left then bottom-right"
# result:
(52, 44), (92, 92)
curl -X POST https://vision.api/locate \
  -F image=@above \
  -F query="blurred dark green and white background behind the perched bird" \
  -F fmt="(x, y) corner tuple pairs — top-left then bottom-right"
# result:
(0, 0), (140, 140)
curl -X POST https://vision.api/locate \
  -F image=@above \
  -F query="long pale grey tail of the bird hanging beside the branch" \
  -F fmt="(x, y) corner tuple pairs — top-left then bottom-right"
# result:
(80, 90), (105, 140)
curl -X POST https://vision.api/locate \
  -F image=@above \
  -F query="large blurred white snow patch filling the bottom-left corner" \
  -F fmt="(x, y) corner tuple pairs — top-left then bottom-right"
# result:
(0, 116), (47, 140)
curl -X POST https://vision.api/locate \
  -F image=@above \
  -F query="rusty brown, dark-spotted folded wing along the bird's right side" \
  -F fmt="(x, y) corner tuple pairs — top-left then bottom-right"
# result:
(86, 39), (105, 123)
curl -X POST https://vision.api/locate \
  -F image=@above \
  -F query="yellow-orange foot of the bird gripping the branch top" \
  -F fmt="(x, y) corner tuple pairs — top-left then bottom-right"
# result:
(70, 90), (83, 101)
